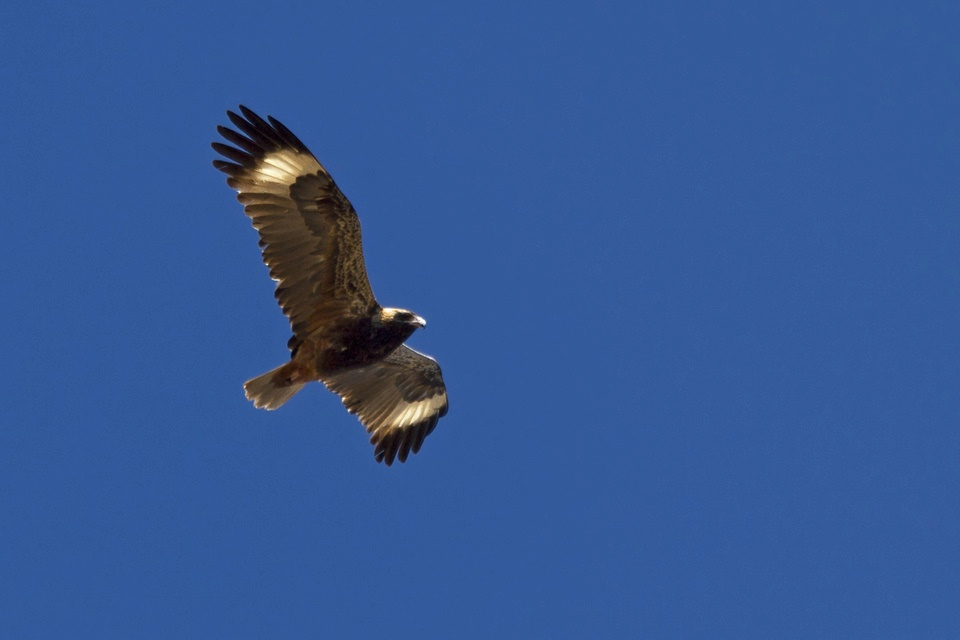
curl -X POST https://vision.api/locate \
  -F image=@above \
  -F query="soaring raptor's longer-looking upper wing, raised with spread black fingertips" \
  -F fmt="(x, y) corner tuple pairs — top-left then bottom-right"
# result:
(212, 105), (377, 342)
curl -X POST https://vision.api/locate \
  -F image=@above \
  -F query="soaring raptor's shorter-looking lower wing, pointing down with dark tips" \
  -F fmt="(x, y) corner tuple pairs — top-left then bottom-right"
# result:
(323, 345), (447, 466)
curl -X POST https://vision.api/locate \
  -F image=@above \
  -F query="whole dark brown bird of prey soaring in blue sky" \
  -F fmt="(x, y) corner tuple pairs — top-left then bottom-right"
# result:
(212, 105), (447, 466)
